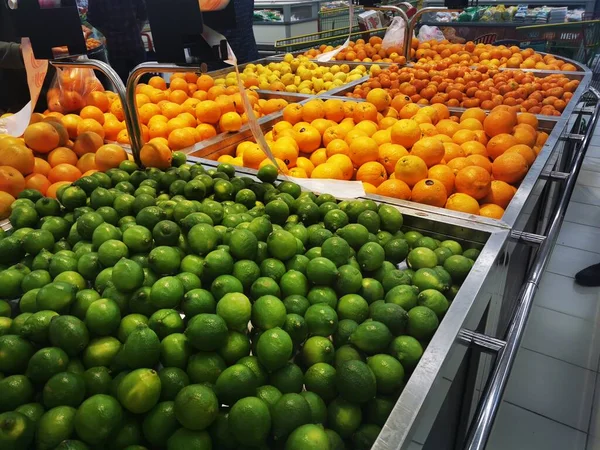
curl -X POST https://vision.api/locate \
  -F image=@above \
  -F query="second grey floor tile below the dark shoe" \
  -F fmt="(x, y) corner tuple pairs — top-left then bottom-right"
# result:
(521, 306), (600, 371)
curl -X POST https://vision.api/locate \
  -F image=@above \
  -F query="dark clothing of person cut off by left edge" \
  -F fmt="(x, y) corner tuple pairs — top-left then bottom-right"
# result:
(0, 0), (29, 112)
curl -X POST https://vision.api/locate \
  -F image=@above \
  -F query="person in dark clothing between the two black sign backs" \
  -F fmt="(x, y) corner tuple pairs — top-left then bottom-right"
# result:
(87, 0), (148, 83)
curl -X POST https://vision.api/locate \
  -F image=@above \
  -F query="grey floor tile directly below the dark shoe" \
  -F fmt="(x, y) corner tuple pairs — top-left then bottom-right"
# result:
(533, 272), (600, 323)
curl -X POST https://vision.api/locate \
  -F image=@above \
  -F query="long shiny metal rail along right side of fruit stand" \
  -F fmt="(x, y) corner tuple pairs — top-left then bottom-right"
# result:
(464, 88), (600, 450)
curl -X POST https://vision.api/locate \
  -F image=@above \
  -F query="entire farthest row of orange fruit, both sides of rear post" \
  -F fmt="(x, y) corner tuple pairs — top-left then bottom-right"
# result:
(304, 36), (578, 72)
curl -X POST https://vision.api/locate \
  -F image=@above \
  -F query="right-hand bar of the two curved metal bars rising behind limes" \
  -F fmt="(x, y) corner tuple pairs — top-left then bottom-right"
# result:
(125, 62), (194, 164)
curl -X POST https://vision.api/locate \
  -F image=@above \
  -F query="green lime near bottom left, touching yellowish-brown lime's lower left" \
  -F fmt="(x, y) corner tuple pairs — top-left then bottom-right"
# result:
(75, 394), (123, 445)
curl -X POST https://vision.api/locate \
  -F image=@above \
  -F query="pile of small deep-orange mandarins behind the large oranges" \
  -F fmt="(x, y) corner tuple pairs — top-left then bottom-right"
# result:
(346, 64), (579, 116)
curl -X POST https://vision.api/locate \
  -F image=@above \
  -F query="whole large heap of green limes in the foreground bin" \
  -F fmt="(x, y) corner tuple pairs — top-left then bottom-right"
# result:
(0, 162), (478, 450)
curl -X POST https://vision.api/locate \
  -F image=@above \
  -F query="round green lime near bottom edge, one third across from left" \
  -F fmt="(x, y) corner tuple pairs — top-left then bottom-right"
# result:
(175, 384), (219, 431)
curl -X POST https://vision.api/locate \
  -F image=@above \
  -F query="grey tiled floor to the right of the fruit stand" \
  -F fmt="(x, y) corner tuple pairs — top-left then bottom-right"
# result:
(487, 137), (600, 450)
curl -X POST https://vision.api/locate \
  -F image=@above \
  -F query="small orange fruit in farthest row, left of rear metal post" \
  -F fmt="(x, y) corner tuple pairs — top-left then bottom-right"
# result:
(304, 36), (406, 64)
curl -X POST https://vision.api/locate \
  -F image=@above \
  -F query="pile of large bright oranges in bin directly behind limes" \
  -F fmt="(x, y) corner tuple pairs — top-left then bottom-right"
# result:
(219, 96), (548, 218)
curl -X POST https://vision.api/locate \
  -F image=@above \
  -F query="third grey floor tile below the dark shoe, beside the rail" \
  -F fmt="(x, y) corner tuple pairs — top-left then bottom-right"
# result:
(504, 348), (596, 430)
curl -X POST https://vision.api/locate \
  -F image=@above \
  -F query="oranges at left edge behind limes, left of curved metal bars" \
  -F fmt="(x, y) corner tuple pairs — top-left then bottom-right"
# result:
(0, 113), (129, 215)
